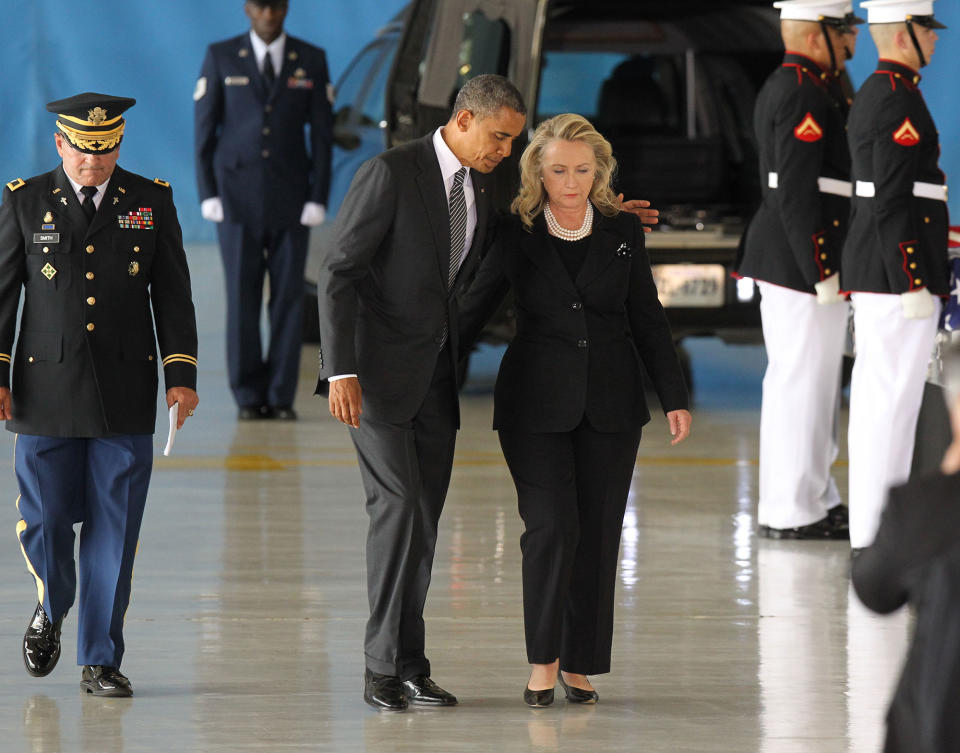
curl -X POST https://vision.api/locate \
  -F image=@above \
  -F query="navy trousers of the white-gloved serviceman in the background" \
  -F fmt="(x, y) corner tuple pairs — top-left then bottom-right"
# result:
(217, 222), (310, 408)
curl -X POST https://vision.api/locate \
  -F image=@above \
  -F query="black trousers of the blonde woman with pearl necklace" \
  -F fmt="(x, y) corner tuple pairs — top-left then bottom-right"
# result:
(499, 420), (640, 675)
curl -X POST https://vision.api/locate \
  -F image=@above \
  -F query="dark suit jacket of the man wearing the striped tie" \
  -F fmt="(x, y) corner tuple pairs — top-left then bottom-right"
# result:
(317, 133), (490, 423)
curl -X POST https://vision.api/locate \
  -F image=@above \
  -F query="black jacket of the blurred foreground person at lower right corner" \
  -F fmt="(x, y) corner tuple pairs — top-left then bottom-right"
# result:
(853, 474), (960, 753)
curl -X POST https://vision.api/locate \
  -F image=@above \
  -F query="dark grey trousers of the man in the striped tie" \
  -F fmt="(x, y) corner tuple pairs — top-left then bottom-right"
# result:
(350, 348), (457, 679)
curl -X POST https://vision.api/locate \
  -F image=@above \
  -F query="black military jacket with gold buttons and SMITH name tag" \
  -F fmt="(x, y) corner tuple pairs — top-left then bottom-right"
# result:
(0, 167), (197, 437)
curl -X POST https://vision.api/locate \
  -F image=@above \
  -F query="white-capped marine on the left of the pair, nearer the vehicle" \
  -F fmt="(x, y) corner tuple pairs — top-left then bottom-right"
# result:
(739, 0), (859, 539)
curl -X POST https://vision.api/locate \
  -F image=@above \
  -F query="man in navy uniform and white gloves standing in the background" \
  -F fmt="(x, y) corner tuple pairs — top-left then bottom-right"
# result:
(193, 0), (333, 420)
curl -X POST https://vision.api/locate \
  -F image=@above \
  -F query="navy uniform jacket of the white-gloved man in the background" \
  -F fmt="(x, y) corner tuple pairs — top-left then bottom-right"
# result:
(194, 33), (333, 227)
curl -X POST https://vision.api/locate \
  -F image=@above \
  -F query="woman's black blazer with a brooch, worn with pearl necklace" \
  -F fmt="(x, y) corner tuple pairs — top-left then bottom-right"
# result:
(461, 212), (688, 433)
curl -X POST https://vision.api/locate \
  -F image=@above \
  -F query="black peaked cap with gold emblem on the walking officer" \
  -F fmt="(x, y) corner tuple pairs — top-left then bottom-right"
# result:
(47, 92), (137, 154)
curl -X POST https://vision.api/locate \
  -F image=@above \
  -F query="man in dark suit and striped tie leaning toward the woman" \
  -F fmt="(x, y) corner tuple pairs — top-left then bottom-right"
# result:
(317, 75), (526, 709)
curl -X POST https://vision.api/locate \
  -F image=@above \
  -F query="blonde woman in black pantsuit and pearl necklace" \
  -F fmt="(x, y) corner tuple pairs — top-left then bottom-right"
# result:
(461, 114), (691, 706)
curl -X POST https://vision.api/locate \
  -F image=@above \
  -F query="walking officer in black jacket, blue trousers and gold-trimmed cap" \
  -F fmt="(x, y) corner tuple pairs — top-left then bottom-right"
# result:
(0, 93), (197, 696)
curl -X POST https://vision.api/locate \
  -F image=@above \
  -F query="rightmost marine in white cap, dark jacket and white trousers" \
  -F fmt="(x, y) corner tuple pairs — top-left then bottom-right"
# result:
(840, 0), (949, 549)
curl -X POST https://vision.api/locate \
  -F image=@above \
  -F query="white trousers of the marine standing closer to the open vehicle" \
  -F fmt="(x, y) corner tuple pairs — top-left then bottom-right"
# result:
(757, 282), (848, 528)
